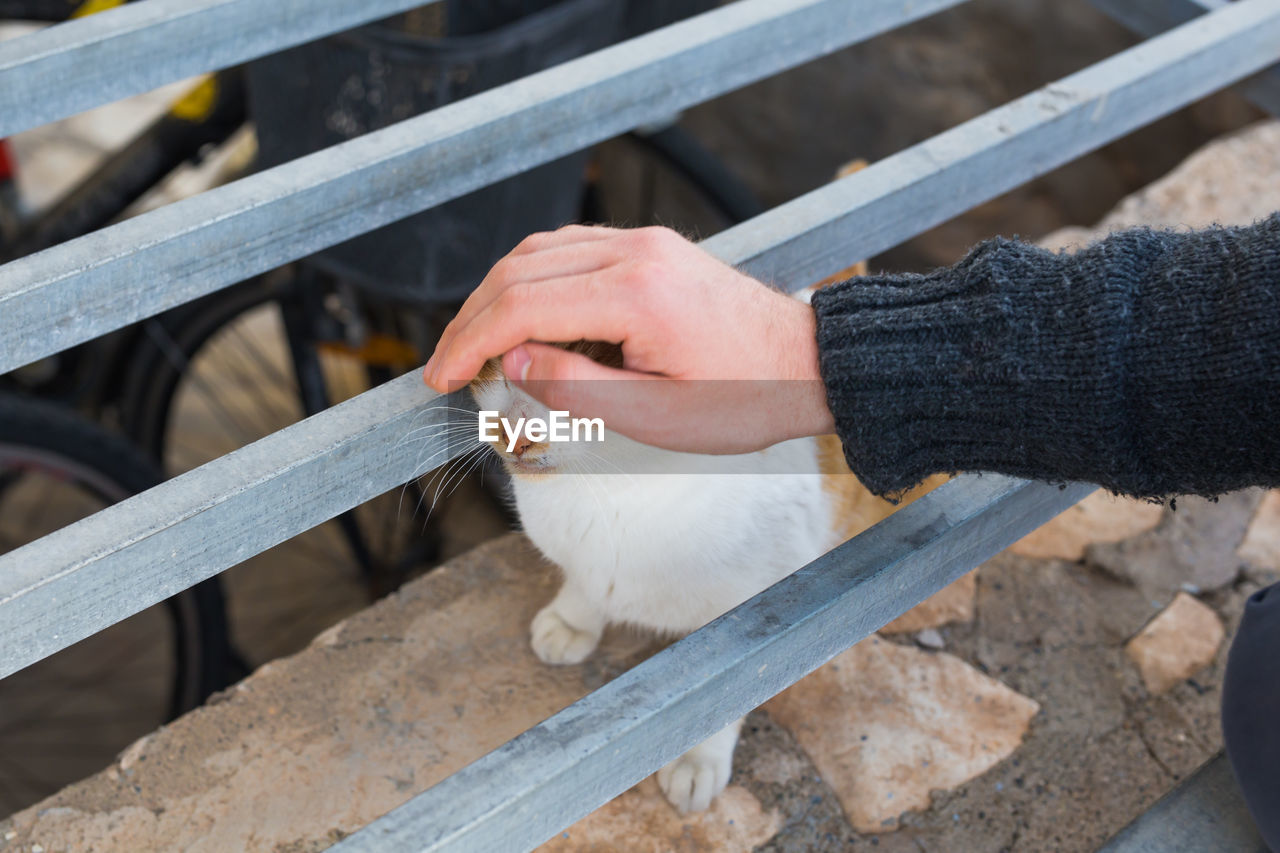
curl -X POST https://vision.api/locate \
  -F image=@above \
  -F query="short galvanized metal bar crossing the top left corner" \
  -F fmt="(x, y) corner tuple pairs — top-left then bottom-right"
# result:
(0, 0), (436, 137)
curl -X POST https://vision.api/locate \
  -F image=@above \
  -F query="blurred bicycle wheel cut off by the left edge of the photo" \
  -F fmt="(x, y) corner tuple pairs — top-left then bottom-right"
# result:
(0, 394), (228, 815)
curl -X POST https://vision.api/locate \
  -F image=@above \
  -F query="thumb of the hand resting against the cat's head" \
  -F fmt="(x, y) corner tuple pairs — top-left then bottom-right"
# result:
(502, 342), (663, 435)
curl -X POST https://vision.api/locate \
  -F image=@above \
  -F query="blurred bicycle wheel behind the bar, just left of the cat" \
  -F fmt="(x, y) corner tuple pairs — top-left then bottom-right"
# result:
(122, 268), (468, 666)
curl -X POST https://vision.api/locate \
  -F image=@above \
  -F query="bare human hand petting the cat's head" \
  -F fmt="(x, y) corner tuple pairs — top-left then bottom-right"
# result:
(424, 225), (835, 453)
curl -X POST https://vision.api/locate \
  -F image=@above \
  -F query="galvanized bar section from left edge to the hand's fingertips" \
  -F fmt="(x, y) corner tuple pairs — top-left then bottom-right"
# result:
(0, 375), (472, 678)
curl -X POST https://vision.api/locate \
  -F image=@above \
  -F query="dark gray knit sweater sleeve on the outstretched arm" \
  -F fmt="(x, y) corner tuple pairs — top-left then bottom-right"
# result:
(813, 215), (1280, 497)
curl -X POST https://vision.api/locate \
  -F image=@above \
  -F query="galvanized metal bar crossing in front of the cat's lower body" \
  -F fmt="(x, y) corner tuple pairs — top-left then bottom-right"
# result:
(330, 475), (1093, 853)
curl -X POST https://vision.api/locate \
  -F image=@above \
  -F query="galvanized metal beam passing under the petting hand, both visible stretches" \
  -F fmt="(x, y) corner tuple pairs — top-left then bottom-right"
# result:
(0, 0), (1280, 678)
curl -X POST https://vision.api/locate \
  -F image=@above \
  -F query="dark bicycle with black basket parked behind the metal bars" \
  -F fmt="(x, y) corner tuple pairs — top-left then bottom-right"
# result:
(6, 0), (762, 666)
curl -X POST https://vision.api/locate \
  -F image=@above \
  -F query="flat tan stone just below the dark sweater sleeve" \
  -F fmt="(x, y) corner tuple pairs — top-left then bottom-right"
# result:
(1009, 489), (1165, 560)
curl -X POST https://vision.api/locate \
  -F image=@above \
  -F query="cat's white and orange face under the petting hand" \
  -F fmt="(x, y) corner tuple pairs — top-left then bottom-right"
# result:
(470, 341), (625, 478)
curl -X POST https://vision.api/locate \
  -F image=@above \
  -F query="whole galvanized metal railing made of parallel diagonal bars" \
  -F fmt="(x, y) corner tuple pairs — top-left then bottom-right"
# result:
(0, 0), (1280, 850)
